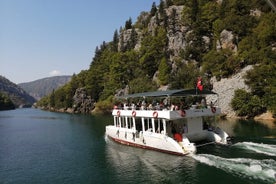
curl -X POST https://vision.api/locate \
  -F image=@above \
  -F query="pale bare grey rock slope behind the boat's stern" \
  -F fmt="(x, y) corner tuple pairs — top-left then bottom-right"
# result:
(207, 65), (253, 117)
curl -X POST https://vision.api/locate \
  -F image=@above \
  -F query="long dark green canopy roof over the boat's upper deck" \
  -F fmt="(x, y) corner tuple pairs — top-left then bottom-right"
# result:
(117, 89), (217, 99)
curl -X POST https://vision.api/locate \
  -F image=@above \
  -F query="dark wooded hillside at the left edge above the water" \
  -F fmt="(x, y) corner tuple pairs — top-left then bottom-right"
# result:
(0, 75), (36, 107)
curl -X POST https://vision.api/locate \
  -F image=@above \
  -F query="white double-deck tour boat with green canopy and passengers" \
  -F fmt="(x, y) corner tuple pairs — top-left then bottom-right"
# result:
(106, 89), (231, 155)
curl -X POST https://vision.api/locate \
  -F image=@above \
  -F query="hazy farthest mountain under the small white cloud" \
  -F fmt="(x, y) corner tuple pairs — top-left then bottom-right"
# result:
(18, 75), (71, 100)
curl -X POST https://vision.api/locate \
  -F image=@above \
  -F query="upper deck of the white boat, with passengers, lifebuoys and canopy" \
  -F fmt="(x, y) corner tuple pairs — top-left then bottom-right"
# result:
(112, 89), (221, 120)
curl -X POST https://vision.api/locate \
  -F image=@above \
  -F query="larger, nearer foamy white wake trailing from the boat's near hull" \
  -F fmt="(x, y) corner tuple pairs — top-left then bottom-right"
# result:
(192, 154), (276, 182)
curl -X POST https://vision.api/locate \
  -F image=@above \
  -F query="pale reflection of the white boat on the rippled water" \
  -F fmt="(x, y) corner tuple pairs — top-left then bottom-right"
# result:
(106, 138), (197, 183)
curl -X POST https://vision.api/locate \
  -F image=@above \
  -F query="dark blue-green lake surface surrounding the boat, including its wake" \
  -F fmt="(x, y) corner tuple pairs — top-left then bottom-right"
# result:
(0, 109), (276, 184)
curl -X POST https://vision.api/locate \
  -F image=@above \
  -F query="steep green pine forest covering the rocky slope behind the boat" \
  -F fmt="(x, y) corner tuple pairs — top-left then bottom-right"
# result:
(37, 0), (276, 117)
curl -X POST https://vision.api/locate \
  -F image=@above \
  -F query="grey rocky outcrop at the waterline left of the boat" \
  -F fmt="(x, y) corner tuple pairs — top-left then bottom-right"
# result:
(70, 88), (95, 114)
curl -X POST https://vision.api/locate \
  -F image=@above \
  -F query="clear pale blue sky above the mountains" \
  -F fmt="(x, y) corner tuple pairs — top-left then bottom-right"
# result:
(0, 0), (156, 83)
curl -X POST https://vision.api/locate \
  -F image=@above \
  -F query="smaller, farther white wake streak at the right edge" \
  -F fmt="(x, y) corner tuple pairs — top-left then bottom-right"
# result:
(233, 142), (276, 156)
